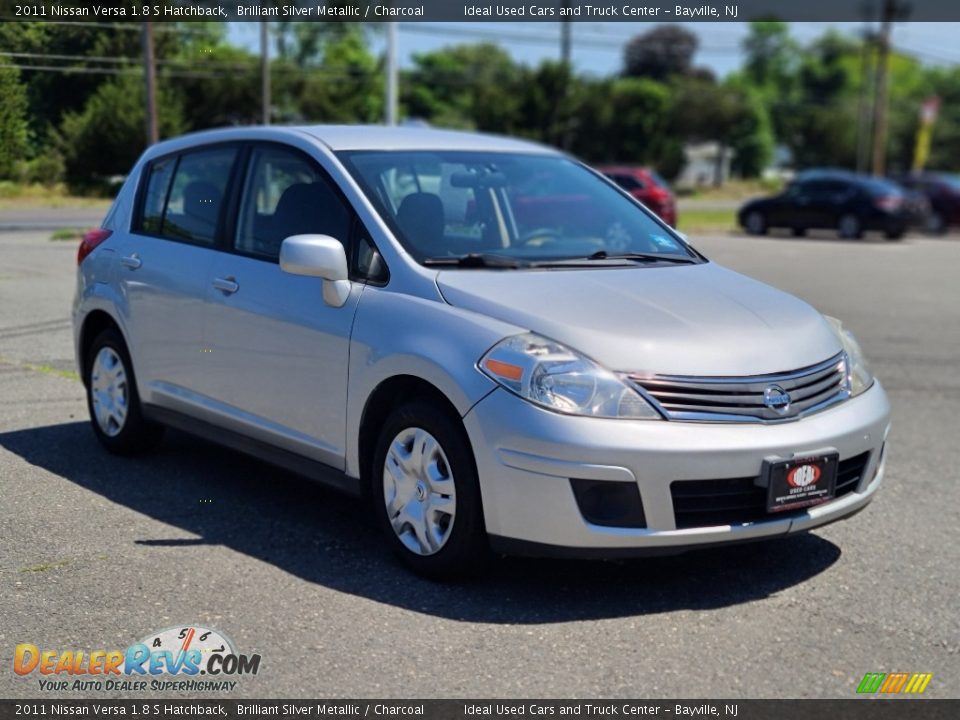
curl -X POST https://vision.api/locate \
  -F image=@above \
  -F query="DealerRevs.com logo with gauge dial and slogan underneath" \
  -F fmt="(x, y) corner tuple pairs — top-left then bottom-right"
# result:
(13, 625), (260, 692)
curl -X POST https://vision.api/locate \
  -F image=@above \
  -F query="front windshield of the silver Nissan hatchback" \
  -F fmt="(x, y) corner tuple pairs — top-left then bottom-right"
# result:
(340, 151), (697, 262)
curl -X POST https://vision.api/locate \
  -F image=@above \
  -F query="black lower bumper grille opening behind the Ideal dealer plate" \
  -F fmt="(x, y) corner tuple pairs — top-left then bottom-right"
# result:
(670, 452), (870, 530)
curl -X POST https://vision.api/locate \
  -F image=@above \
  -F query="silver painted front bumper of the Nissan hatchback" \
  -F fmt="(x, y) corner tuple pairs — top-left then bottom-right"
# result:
(464, 382), (890, 557)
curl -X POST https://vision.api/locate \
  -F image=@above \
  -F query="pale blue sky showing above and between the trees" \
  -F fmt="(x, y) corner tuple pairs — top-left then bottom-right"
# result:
(230, 22), (960, 76)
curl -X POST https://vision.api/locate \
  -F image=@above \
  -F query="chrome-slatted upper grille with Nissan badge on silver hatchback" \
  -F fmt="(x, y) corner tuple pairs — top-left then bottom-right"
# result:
(627, 353), (850, 422)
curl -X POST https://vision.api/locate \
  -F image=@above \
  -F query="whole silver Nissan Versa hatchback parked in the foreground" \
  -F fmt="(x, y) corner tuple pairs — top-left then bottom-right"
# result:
(73, 127), (890, 577)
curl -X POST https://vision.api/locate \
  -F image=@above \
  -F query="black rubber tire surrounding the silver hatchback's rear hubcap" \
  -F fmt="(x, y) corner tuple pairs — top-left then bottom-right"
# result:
(83, 328), (164, 455)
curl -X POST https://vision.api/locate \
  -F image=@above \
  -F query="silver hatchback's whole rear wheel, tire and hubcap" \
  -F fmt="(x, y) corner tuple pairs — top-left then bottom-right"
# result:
(84, 328), (163, 455)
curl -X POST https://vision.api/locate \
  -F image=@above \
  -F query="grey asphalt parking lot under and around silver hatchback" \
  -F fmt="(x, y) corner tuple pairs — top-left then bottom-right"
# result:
(0, 226), (960, 698)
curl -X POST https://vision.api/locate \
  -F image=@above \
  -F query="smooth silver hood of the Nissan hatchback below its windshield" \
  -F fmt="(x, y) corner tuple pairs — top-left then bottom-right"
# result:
(437, 263), (841, 375)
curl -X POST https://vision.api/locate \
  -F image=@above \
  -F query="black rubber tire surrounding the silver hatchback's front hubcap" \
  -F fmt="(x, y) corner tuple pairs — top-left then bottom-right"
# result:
(369, 400), (490, 580)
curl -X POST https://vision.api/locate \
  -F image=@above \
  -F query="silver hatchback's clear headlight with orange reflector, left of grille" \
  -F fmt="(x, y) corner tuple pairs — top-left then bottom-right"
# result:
(479, 333), (660, 420)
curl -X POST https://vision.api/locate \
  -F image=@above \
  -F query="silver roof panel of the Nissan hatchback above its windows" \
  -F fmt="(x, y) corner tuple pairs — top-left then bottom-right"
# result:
(143, 125), (561, 155)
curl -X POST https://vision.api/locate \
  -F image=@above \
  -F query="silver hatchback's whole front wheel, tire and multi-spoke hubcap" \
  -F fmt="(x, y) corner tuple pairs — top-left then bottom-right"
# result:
(371, 401), (489, 580)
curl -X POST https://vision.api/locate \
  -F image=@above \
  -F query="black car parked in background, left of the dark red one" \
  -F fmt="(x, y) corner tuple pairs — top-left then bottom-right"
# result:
(737, 171), (911, 240)
